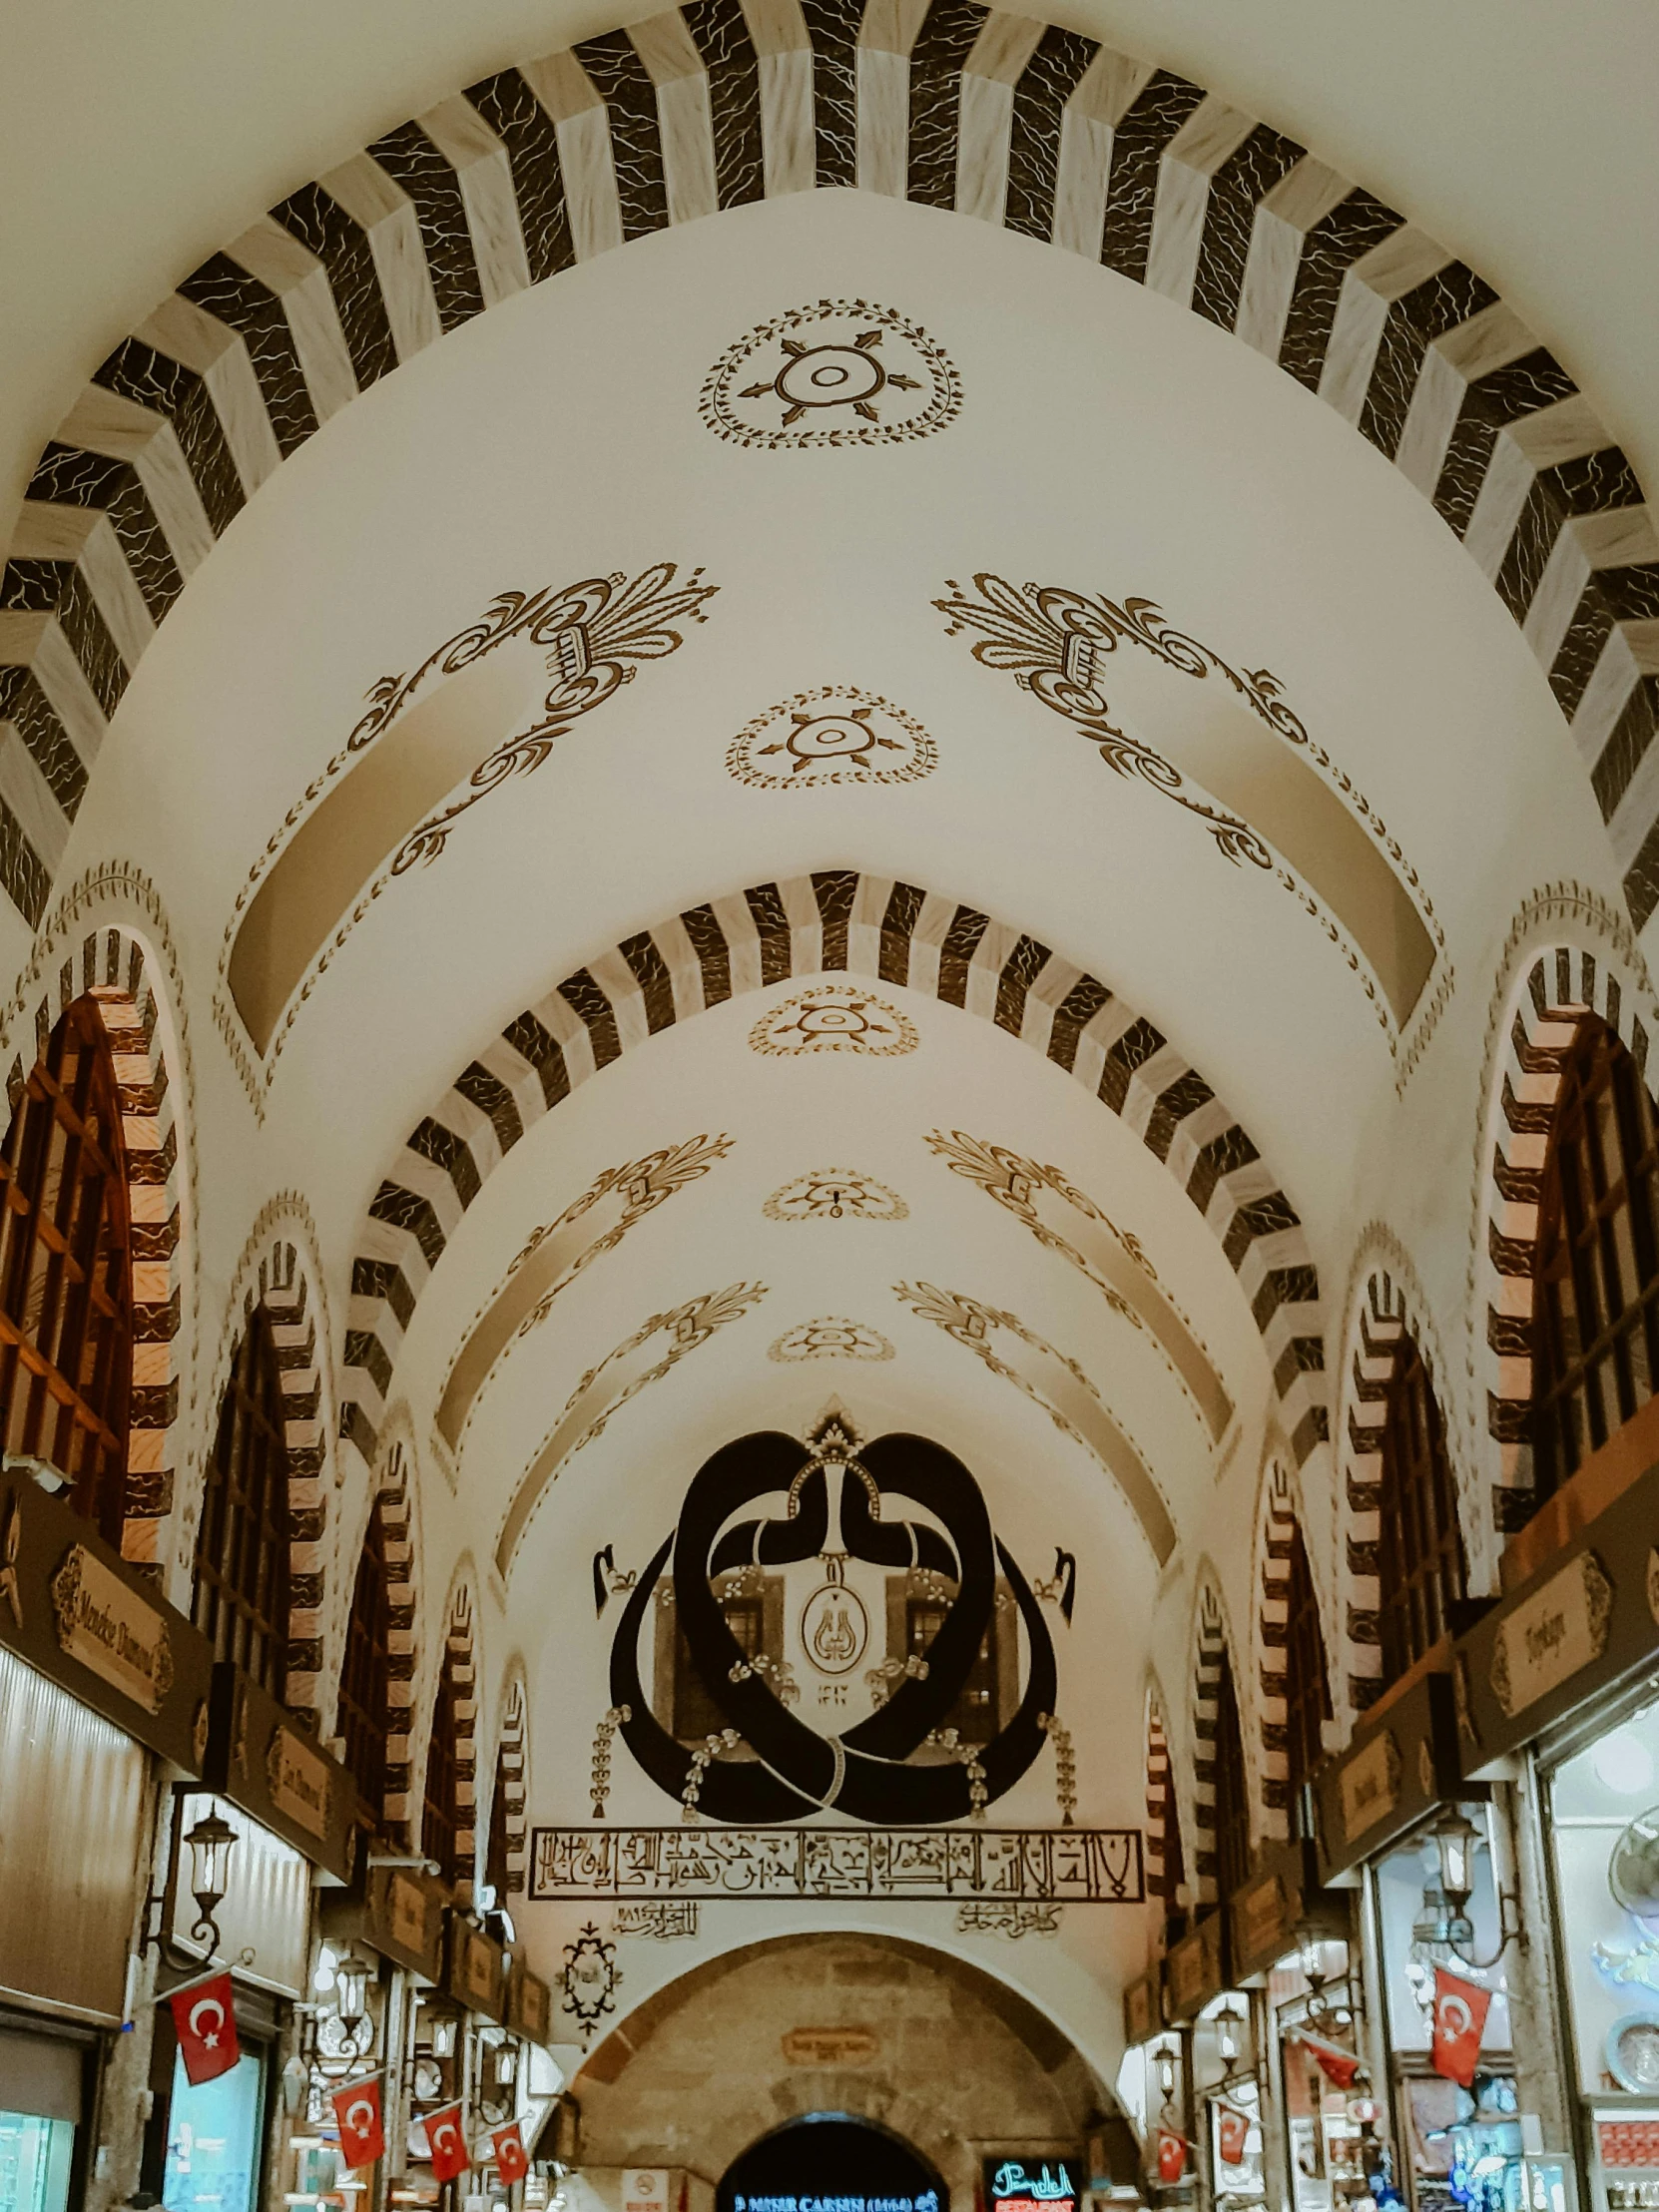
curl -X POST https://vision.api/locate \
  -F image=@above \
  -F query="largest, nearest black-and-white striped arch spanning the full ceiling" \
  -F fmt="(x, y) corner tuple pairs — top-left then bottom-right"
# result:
(0, 0), (1659, 927)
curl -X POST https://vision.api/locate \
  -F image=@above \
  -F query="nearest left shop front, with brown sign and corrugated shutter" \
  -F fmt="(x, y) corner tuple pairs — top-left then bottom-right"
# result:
(0, 1462), (213, 2212)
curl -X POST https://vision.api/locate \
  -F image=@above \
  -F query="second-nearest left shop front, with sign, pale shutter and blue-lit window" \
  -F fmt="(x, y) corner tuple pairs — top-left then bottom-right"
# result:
(144, 1661), (356, 2212)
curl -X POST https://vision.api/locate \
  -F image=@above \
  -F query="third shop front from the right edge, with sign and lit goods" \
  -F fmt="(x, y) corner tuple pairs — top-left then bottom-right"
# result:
(1219, 1843), (1376, 2212)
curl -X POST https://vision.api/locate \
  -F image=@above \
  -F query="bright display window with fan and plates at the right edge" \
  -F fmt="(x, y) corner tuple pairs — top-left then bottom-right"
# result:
(1550, 1703), (1659, 2208)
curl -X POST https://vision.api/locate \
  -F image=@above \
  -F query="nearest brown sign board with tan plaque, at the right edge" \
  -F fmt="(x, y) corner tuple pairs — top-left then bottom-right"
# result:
(1451, 1466), (1659, 1779)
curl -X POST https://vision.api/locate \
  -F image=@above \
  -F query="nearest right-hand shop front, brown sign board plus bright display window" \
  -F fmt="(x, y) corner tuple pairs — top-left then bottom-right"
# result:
(1455, 1441), (1659, 2212)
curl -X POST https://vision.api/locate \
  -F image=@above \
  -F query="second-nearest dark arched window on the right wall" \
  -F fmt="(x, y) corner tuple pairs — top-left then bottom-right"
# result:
(1376, 1336), (1464, 1686)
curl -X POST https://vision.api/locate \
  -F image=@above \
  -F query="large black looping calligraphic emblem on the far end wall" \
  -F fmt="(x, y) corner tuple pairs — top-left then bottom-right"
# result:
(611, 1433), (1055, 1827)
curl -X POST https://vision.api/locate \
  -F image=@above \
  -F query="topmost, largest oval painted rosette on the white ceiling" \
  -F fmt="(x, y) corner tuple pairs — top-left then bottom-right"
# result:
(697, 298), (962, 453)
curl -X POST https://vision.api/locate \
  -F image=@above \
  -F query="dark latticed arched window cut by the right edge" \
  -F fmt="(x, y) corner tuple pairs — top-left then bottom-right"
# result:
(1533, 1017), (1659, 1502)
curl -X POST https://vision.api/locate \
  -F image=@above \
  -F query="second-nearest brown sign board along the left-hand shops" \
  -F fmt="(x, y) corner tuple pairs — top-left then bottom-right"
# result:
(204, 1659), (358, 1883)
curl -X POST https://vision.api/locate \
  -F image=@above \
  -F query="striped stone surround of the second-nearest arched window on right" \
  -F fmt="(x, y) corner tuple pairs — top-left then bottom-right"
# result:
(1332, 1223), (1488, 1725)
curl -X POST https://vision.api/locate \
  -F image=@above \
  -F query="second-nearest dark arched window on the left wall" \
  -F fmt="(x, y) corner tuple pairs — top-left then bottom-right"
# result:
(191, 1308), (289, 1697)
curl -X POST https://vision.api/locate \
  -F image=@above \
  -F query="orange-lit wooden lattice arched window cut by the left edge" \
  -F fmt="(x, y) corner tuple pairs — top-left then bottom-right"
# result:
(0, 997), (133, 1544)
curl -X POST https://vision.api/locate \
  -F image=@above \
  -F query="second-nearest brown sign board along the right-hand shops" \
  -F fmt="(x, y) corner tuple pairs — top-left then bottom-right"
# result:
(1314, 1675), (1464, 1887)
